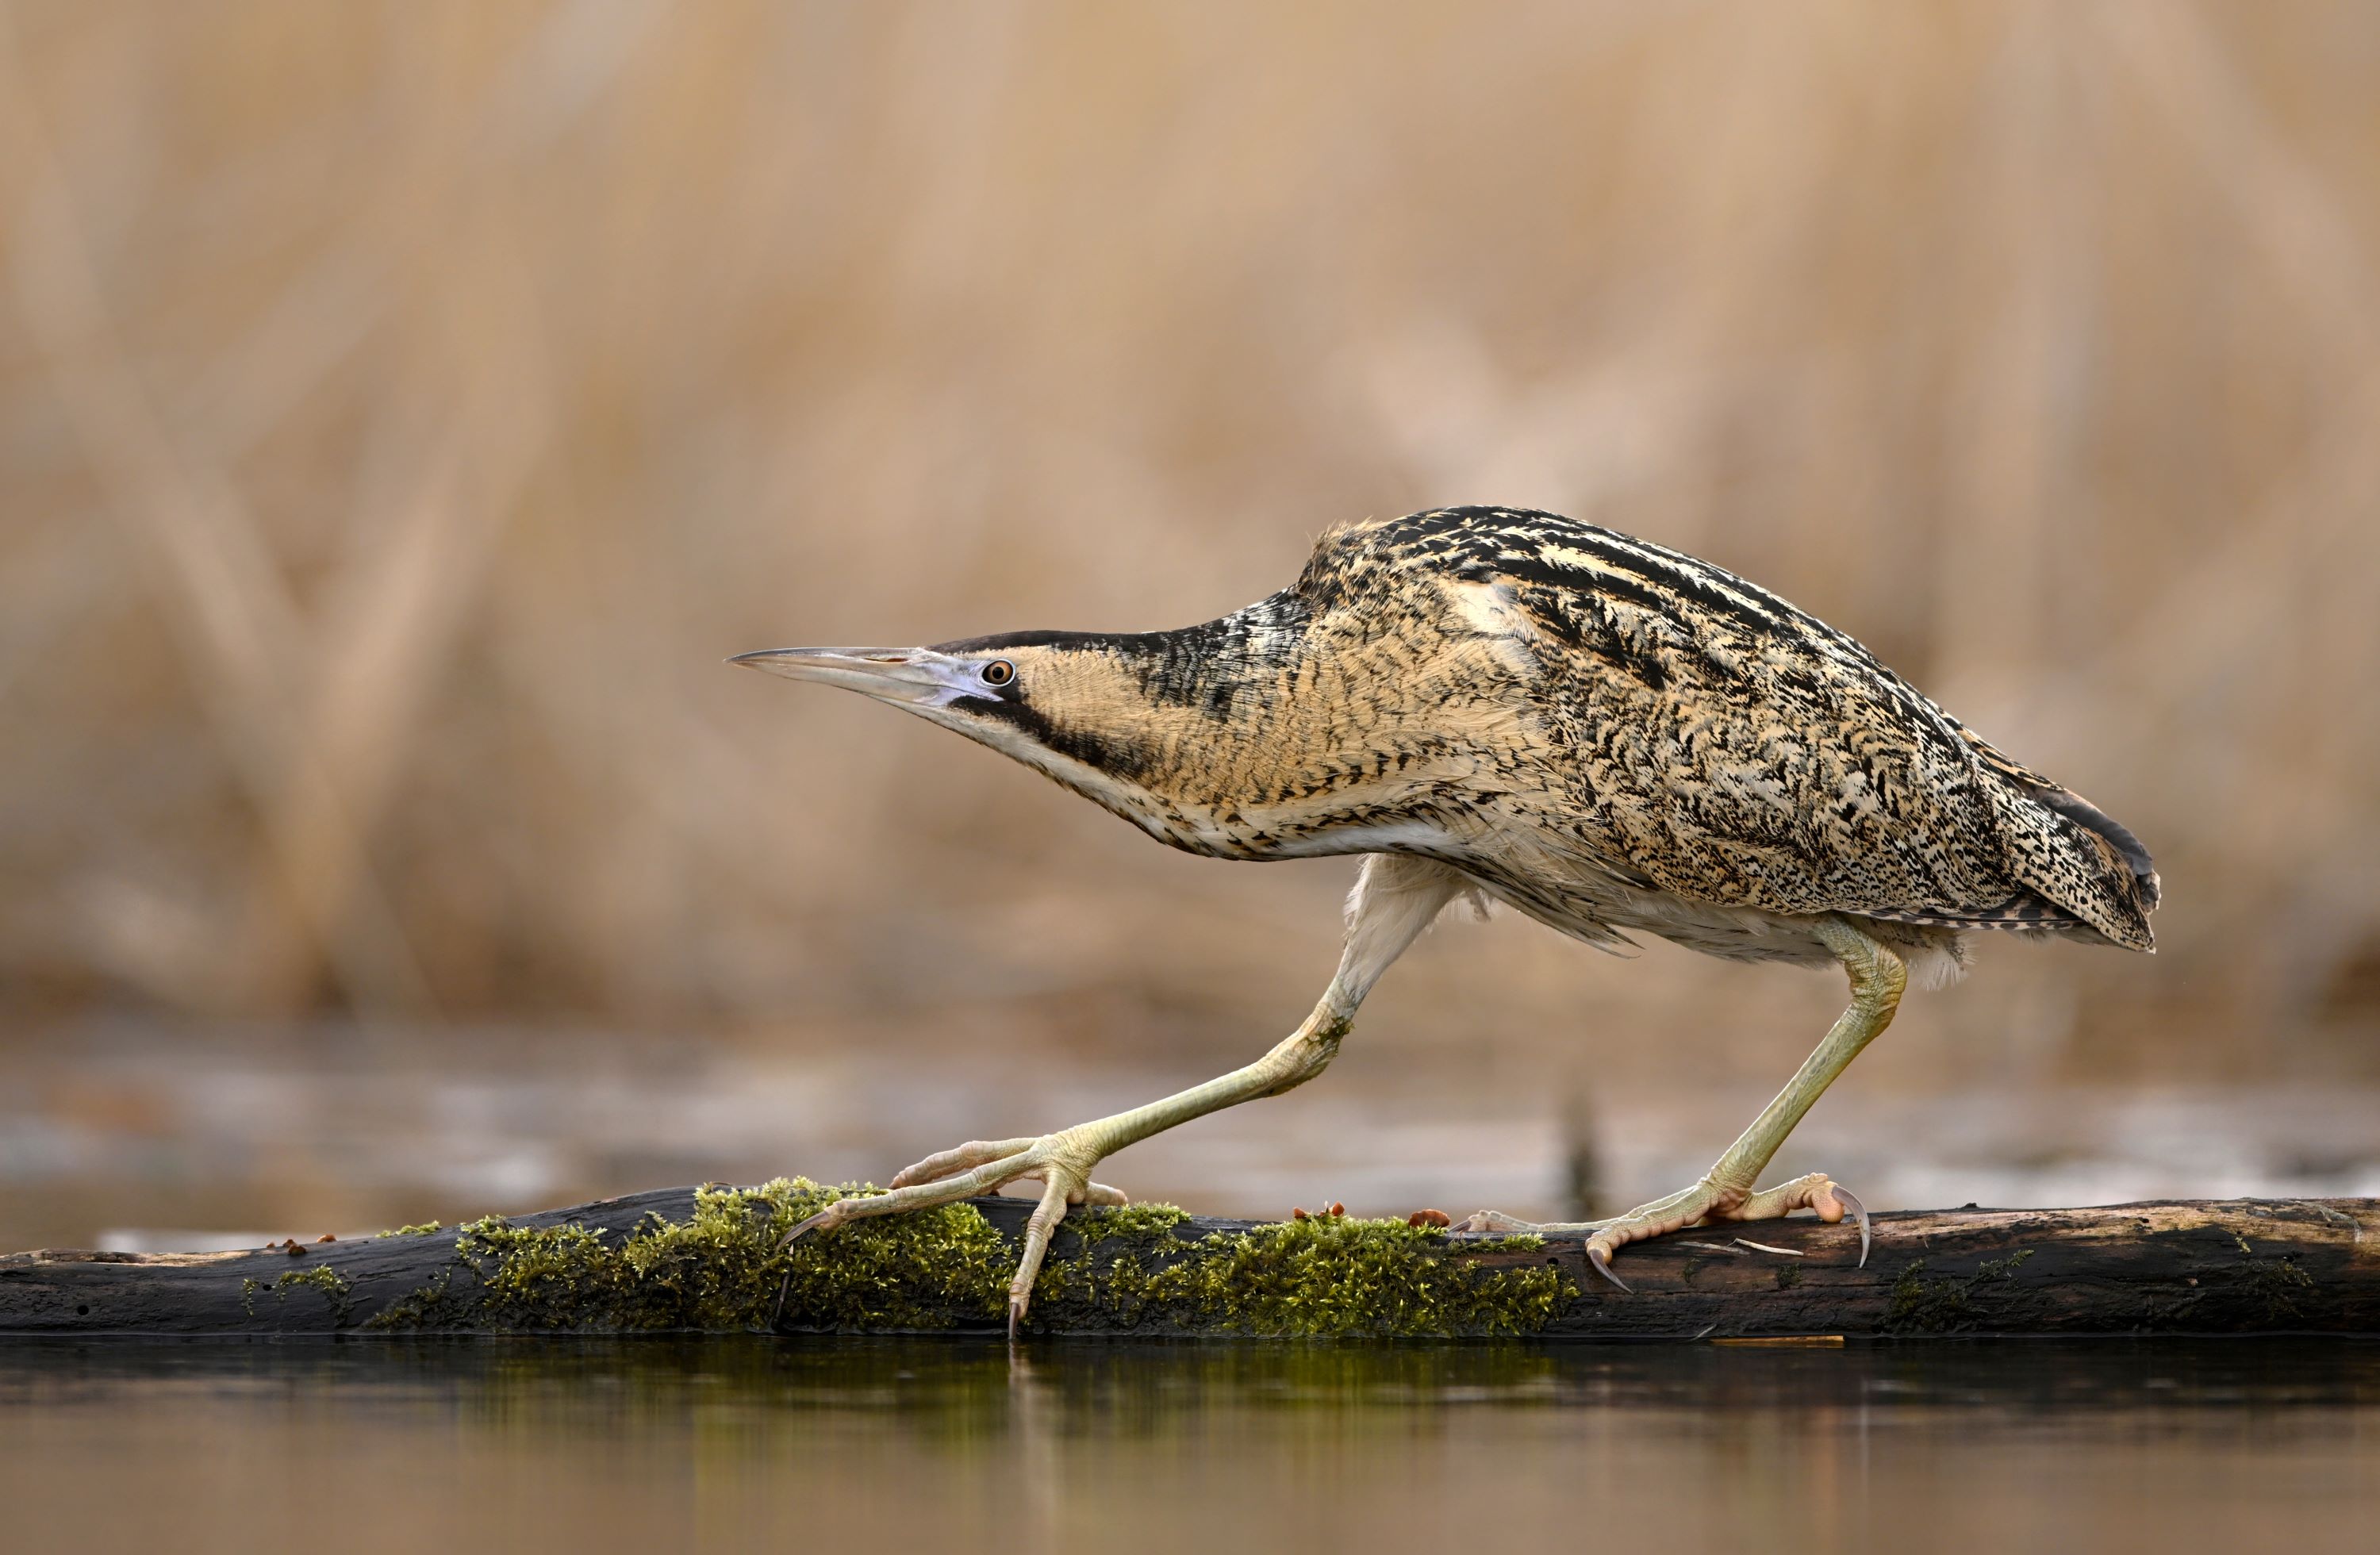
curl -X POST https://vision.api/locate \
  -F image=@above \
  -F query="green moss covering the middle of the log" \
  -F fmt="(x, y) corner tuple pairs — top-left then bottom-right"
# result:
(369, 1179), (1578, 1336)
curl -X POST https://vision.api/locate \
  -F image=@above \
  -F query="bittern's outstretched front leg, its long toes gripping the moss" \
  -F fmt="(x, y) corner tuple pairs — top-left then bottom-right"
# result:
(785, 853), (1464, 1334)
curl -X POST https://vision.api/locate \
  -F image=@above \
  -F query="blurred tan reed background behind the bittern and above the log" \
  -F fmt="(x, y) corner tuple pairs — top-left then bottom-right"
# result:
(0, 0), (2380, 1246)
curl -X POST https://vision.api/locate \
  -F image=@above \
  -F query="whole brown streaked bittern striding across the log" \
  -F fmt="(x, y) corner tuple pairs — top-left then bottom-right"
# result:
(735, 507), (2156, 1331)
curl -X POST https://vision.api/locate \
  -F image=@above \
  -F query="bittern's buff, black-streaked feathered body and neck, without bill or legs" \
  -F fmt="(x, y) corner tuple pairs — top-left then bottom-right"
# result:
(942, 507), (2156, 960)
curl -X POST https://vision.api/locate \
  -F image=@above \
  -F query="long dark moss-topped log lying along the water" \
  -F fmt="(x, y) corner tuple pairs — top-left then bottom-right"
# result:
(0, 1184), (2380, 1338)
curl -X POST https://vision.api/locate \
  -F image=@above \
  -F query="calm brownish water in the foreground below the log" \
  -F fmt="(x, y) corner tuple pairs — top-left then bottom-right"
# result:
(0, 1341), (2380, 1555)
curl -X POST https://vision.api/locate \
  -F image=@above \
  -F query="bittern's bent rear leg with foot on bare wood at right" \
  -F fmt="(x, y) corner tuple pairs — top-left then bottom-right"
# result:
(1457, 915), (1909, 1291)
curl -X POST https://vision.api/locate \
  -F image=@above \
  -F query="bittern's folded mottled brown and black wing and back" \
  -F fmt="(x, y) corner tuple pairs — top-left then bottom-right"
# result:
(1323, 509), (2154, 948)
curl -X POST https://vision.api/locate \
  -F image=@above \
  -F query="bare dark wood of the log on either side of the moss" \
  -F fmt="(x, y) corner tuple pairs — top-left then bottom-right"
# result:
(0, 1188), (2380, 1341)
